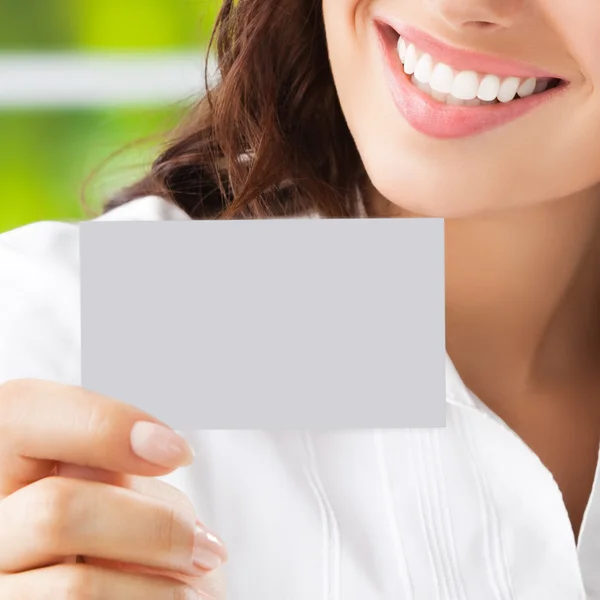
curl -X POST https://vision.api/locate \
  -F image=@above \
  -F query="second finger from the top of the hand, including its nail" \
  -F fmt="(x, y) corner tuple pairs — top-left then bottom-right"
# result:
(0, 477), (226, 575)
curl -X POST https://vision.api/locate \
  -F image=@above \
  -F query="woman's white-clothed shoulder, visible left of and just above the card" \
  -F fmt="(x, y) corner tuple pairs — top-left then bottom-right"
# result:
(0, 196), (188, 384)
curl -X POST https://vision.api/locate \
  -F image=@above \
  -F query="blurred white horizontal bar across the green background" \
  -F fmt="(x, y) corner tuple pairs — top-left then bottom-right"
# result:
(0, 49), (215, 109)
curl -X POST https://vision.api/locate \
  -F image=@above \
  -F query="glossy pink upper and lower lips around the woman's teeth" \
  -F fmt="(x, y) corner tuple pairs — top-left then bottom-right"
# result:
(375, 19), (567, 139)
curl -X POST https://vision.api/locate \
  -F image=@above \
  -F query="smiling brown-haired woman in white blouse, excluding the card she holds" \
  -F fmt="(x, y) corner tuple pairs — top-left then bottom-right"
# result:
(0, 0), (600, 600)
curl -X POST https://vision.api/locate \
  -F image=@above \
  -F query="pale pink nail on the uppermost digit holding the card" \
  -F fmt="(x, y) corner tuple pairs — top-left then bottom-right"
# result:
(131, 421), (194, 469)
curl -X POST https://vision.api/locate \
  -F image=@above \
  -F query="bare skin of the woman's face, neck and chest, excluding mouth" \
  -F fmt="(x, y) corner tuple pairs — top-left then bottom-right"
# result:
(323, 0), (600, 536)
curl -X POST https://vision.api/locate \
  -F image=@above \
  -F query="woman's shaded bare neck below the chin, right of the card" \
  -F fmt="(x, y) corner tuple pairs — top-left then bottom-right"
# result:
(369, 190), (600, 404)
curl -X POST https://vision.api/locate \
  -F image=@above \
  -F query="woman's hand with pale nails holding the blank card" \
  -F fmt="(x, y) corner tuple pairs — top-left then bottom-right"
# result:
(0, 381), (226, 600)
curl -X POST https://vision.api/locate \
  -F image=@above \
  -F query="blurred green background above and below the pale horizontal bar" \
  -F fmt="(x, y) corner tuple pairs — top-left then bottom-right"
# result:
(0, 0), (220, 232)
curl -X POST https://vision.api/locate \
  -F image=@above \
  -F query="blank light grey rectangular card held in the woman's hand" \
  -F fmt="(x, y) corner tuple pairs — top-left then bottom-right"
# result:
(80, 219), (446, 430)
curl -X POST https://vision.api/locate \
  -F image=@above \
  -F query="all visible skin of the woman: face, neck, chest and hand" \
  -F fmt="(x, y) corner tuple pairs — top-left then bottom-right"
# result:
(0, 0), (600, 600)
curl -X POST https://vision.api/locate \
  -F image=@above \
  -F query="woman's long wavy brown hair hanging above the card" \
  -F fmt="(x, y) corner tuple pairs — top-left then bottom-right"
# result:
(106, 0), (365, 219)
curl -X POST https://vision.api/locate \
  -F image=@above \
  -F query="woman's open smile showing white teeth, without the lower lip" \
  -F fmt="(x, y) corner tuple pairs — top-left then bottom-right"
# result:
(378, 23), (568, 107)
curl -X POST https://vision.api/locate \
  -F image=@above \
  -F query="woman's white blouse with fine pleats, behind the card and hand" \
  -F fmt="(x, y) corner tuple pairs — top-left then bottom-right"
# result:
(0, 197), (600, 600)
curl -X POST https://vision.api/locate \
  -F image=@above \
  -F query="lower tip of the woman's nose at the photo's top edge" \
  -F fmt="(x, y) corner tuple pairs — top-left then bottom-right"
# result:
(427, 0), (527, 30)
